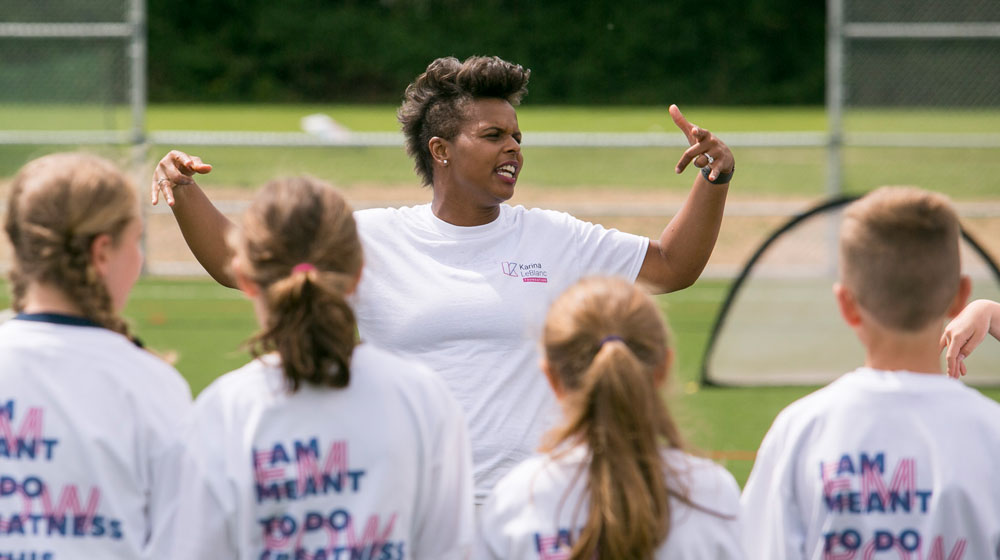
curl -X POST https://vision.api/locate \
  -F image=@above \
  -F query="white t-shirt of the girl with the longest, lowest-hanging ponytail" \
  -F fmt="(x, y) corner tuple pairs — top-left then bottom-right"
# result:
(475, 448), (743, 560)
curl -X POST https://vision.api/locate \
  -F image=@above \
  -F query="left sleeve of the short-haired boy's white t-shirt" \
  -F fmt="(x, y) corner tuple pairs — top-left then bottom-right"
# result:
(740, 415), (806, 560)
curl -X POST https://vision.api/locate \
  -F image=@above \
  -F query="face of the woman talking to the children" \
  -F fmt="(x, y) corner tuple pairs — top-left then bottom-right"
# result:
(446, 99), (524, 206)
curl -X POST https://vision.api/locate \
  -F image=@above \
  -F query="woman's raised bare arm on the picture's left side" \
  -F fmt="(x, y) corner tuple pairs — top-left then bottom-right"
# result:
(150, 150), (236, 288)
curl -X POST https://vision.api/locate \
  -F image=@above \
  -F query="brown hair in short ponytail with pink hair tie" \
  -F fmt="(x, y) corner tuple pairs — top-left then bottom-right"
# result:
(234, 177), (361, 391)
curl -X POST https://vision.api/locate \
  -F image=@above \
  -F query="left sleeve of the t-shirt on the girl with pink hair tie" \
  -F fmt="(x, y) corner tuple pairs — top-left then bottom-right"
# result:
(152, 384), (239, 558)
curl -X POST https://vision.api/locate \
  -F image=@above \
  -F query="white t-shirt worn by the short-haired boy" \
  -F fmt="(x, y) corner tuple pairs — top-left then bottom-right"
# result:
(742, 368), (1000, 560)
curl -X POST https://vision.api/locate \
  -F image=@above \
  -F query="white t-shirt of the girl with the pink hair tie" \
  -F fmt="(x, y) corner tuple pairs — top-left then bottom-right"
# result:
(161, 344), (475, 560)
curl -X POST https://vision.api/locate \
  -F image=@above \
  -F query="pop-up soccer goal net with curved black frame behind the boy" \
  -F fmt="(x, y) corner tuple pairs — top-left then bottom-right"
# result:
(702, 197), (1000, 386)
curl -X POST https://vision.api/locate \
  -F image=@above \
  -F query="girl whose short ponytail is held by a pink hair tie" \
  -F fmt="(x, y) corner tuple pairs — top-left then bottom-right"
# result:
(162, 178), (474, 560)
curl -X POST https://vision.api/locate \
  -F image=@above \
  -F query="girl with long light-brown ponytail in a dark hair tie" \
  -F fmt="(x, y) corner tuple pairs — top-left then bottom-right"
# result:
(476, 277), (742, 560)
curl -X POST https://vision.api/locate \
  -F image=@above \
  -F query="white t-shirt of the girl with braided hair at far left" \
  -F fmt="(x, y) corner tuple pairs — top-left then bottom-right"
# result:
(0, 315), (191, 560)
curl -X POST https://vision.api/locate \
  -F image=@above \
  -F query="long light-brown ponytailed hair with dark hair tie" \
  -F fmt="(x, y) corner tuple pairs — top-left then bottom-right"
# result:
(542, 278), (687, 560)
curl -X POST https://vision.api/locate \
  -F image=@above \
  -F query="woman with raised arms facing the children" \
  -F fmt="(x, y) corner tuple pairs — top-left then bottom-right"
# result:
(152, 56), (734, 503)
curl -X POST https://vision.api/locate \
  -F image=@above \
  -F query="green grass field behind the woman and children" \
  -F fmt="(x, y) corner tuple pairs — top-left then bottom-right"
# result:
(0, 100), (1000, 483)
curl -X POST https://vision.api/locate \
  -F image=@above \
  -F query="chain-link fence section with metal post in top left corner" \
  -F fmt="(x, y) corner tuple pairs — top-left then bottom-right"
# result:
(0, 0), (145, 140)
